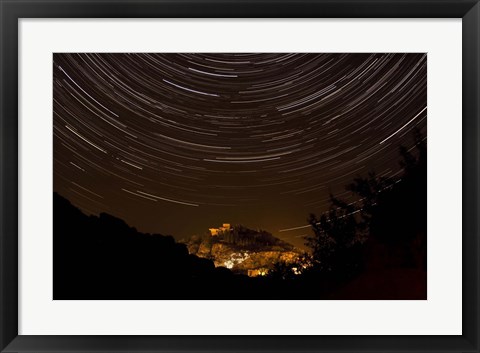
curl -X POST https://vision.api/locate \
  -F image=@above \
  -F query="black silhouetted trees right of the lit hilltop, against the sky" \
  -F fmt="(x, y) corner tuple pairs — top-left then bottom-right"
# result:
(306, 126), (427, 278)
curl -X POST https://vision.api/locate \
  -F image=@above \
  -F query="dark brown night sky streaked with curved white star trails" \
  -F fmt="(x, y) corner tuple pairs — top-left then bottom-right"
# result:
(53, 53), (427, 245)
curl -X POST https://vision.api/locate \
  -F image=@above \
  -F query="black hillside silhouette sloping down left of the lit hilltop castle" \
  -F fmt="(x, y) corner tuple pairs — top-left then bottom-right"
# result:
(54, 193), (232, 299)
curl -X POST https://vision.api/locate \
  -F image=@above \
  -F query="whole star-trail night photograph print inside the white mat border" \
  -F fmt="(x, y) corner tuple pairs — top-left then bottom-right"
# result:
(52, 53), (427, 300)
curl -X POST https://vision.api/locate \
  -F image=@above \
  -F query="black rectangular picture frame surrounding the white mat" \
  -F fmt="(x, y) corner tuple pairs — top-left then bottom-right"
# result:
(0, 0), (480, 352)
